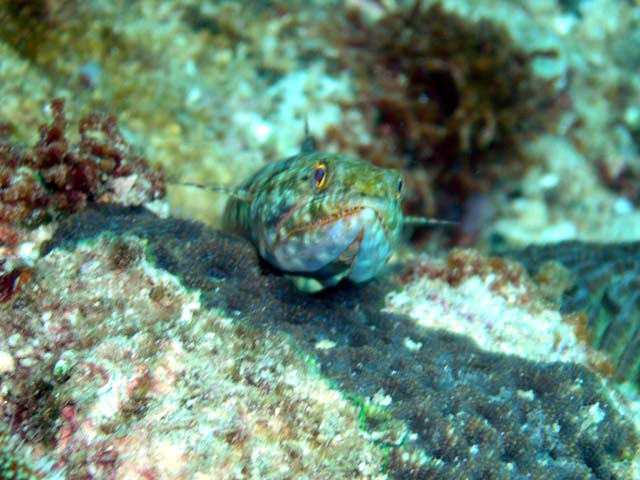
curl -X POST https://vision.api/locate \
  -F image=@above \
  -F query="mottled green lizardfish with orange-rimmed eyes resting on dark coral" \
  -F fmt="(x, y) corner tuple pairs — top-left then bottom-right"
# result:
(223, 152), (404, 290)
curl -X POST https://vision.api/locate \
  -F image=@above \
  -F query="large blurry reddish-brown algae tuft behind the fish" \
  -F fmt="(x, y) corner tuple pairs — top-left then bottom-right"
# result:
(332, 1), (559, 238)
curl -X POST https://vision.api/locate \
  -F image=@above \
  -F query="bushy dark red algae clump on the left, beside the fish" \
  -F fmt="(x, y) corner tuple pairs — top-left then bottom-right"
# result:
(0, 99), (165, 226)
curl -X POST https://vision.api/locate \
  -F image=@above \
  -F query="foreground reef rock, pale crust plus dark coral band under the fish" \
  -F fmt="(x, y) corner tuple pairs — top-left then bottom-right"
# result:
(2, 205), (640, 479)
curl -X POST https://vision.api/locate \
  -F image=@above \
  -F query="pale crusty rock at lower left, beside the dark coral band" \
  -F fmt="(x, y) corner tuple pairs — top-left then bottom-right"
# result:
(0, 226), (383, 480)
